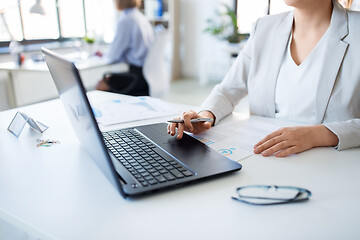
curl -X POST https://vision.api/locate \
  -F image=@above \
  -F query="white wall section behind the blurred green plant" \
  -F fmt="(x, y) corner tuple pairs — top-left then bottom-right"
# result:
(179, 0), (233, 80)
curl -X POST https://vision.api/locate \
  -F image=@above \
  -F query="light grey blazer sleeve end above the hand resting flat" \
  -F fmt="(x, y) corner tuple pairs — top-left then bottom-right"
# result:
(323, 118), (360, 150)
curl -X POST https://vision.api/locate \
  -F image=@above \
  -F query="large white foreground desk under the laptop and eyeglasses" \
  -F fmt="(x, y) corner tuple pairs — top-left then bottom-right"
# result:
(0, 92), (360, 240)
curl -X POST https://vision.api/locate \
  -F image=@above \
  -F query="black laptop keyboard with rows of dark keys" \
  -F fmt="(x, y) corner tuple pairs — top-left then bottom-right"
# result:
(103, 129), (194, 187)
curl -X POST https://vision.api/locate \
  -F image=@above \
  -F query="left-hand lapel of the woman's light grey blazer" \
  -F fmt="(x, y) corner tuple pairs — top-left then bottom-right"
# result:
(264, 11), (293, 118)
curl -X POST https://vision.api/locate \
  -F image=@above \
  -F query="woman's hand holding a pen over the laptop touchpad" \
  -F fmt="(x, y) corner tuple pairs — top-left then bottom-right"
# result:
(167, 110), (215, 139)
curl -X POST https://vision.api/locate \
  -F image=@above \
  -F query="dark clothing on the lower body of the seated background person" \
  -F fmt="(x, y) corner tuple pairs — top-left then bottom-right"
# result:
(104, 65), (149, 96)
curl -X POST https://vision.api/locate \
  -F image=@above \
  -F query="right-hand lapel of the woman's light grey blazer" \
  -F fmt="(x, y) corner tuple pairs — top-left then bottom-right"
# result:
(315, 1), (349, 123)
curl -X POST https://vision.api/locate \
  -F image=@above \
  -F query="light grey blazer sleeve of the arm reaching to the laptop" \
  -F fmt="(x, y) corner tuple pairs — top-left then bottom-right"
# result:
(200, 22), (257, 125)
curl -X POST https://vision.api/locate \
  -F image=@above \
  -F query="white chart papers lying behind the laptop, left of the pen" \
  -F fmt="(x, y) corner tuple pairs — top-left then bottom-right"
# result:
(91, 96), (180, 126)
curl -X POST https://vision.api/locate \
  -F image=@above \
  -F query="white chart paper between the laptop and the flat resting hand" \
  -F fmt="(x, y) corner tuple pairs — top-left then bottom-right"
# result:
(193, 117), (280, 161)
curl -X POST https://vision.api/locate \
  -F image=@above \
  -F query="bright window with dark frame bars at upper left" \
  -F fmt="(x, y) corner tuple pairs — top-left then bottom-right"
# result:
(0, 0), (116, 46)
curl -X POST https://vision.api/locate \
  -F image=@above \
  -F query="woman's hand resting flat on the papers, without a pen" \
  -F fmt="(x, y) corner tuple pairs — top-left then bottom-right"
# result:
(254, 125), (339, 157)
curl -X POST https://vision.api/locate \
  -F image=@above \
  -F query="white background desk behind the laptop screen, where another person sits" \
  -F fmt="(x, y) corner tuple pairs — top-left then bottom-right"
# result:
(0, 57), (128, 107)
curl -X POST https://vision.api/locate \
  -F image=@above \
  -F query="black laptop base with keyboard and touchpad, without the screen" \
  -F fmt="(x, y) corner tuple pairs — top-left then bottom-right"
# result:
(103, 123), (241, 196)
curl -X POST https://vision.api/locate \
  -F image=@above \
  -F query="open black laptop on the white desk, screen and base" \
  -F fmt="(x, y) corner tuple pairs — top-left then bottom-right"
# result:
(42, 48), (241, 197)
